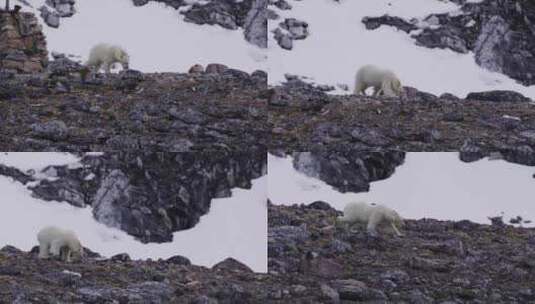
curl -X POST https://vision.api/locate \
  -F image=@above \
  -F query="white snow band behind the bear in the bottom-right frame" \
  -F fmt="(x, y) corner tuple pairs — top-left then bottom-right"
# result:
(268, 152), (535, 227)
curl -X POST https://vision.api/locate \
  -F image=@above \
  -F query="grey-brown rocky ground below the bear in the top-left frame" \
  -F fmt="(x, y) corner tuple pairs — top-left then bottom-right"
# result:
(0, 62), (267, 152)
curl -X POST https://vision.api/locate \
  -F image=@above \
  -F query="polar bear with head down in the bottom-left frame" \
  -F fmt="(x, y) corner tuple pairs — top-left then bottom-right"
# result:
(37, 226), (84, 263)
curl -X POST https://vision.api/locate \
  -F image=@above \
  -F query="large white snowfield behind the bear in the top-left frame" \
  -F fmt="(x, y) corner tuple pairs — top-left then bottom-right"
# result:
(23, 0), (266, 72)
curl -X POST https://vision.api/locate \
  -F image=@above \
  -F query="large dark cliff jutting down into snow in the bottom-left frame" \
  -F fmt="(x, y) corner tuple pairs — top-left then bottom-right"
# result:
(0, 150), (267, 243)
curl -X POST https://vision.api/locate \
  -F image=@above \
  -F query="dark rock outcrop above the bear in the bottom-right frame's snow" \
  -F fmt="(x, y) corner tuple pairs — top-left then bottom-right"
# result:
(292, 151), (405, 192)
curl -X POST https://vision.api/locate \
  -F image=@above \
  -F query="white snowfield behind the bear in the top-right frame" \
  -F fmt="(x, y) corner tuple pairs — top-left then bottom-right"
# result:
(268, 0), (535, 98)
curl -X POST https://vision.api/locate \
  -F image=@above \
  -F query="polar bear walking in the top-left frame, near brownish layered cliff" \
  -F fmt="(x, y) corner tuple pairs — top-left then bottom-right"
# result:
(85, 43), (130, 74)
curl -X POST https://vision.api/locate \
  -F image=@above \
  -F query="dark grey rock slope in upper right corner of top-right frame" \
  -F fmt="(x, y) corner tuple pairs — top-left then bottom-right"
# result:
(362, 0), (535, 85)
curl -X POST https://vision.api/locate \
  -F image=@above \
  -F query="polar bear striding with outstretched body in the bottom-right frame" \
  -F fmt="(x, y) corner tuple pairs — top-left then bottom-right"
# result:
(337, 202), (404, 236)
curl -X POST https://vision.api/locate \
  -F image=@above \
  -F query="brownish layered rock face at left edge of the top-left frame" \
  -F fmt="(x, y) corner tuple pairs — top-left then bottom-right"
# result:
(0, 11), (48, 73)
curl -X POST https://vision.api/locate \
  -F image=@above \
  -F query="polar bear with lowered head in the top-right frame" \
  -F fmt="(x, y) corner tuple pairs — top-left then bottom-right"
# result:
(354, 65), (402, 97)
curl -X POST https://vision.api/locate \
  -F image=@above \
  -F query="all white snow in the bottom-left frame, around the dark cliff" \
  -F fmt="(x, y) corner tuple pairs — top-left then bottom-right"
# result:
(0, 153), (267, 272)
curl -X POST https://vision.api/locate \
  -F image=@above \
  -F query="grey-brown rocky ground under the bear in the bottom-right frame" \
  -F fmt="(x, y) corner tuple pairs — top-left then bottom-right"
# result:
(268, 202), (535, 303)
